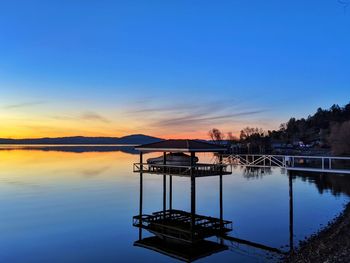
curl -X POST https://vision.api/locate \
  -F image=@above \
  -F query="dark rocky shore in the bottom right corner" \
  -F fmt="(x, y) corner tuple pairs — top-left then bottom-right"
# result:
(284, 203), (350, 263)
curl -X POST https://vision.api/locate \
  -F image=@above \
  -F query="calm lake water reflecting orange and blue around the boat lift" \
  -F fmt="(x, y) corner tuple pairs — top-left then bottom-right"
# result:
(0, 147), (350, 263)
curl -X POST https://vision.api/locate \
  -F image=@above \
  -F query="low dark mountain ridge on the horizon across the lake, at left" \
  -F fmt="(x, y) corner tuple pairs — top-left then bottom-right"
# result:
(0, 134), (162, 144)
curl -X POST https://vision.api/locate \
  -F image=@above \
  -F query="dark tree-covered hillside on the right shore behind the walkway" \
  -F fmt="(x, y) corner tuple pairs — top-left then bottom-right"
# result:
(209, 103), (350, 155)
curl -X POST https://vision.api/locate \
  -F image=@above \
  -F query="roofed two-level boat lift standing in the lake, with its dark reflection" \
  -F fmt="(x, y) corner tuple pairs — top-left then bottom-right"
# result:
(133, 140), (232, 261)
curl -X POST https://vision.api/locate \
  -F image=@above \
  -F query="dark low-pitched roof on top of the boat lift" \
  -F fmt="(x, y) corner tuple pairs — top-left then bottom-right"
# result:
(135, 140), (226, 152)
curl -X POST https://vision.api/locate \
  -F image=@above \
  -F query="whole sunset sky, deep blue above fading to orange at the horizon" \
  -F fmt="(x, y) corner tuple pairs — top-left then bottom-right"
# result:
(0, 0), (350, 139)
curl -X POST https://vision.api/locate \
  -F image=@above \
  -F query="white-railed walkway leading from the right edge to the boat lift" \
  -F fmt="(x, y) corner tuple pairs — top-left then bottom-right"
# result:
(225, 154), (350, 174)
